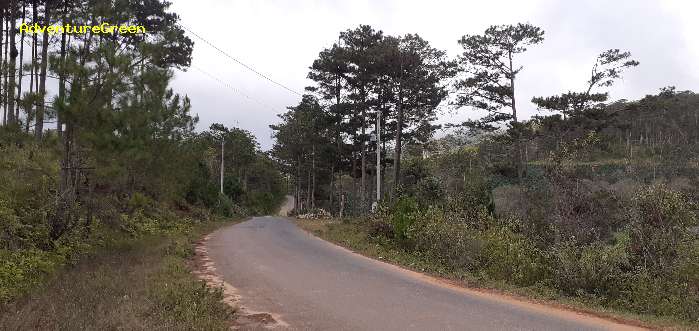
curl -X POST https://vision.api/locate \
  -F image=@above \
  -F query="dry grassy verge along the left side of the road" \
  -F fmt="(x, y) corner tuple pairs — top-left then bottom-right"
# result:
(0, 221), (234, 330)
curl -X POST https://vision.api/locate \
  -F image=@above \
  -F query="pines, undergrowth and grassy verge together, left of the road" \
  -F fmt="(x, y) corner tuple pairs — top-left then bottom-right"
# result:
(0, 0), (285, 330)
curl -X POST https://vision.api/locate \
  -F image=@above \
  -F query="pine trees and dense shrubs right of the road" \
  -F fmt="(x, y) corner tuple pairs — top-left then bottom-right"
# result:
(272, 24), (699, 322)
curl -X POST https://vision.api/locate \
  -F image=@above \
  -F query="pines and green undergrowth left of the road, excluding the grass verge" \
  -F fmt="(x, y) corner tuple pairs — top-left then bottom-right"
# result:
(0, 0), (285, 303)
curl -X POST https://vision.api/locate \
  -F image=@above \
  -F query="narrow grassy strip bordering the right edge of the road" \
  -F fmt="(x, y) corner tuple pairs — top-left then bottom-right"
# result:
(296, 219), (699, 330)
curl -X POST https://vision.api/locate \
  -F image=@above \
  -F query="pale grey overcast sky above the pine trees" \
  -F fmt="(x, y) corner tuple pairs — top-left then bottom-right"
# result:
(171, 0), (699, 150)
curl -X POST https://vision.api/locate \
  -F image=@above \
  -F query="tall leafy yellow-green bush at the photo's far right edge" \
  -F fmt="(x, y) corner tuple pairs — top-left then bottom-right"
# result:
(623, 185), (699, 320)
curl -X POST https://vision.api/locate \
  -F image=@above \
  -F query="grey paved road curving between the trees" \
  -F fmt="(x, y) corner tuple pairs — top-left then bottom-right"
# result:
(207, 216), (644, 330)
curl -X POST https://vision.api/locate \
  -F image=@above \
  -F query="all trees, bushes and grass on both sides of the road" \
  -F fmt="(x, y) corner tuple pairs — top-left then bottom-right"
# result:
(0, 0), (699, 329)
